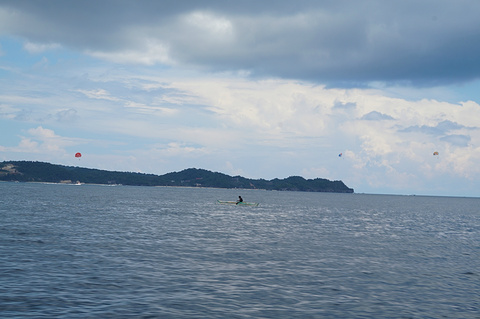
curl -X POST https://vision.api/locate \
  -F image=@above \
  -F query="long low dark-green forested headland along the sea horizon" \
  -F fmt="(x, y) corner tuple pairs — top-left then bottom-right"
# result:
(0, 161), (353, 193)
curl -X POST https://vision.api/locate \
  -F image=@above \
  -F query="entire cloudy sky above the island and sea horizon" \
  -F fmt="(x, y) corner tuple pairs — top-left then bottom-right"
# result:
(0, 0), (480, 197)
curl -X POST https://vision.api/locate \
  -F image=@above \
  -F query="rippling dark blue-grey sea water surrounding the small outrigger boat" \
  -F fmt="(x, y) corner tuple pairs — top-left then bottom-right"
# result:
(0, 183), (480, 318)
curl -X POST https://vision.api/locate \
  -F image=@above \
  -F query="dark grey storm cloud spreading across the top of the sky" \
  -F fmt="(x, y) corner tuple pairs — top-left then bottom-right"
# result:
(0, 0), (480, 85)
